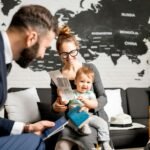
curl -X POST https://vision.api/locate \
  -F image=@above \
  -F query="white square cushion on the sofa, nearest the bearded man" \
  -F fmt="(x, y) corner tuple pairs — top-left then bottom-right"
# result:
(5, 88), (41, 123)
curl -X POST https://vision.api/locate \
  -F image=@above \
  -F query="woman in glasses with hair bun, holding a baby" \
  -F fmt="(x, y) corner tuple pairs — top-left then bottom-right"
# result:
(51, 26), (110, 150)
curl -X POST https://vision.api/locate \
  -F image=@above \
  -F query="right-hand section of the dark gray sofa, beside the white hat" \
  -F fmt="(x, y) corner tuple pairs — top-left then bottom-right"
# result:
(110, 88), (150, 149)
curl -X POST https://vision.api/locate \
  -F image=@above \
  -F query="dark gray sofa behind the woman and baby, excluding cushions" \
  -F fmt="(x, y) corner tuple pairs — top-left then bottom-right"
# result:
(6, 88), (150, 150)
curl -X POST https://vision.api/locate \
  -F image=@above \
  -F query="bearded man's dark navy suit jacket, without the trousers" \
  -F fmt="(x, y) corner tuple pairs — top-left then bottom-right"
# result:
(0, 33), (14, 136)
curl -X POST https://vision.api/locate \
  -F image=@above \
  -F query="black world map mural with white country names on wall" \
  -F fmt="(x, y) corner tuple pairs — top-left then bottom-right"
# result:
(1, 0), (150, 87)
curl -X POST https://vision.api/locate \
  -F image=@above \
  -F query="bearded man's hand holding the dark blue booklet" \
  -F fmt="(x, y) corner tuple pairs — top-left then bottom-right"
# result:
(24, 120), (55, 135)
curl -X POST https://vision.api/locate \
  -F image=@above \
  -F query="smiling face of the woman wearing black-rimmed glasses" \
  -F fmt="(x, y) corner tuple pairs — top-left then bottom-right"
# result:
(60, 41), (78, 64)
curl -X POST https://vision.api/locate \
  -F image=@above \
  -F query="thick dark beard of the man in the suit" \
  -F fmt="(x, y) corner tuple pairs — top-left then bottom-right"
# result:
(16, 42), (39, 68)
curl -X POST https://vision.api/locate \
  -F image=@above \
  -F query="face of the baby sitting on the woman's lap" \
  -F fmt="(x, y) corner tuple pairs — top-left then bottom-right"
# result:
(76, 73), (93, 93)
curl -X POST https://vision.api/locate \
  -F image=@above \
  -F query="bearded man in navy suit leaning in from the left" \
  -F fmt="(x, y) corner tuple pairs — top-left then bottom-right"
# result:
(0, 5), (58, 150)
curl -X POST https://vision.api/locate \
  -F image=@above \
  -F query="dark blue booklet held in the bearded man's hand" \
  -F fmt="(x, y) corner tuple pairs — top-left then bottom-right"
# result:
(43, 117), (68, 140)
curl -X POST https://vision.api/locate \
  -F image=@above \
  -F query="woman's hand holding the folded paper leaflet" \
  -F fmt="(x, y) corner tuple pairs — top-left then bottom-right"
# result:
(53, 97), (68, 112)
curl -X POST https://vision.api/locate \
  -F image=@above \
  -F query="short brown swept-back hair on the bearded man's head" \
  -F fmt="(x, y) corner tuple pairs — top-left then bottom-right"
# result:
(9, 5), (58, 34)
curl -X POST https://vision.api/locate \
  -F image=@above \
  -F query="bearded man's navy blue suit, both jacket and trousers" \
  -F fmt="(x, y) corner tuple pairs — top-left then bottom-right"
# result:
(0, 33), (45, 150)
